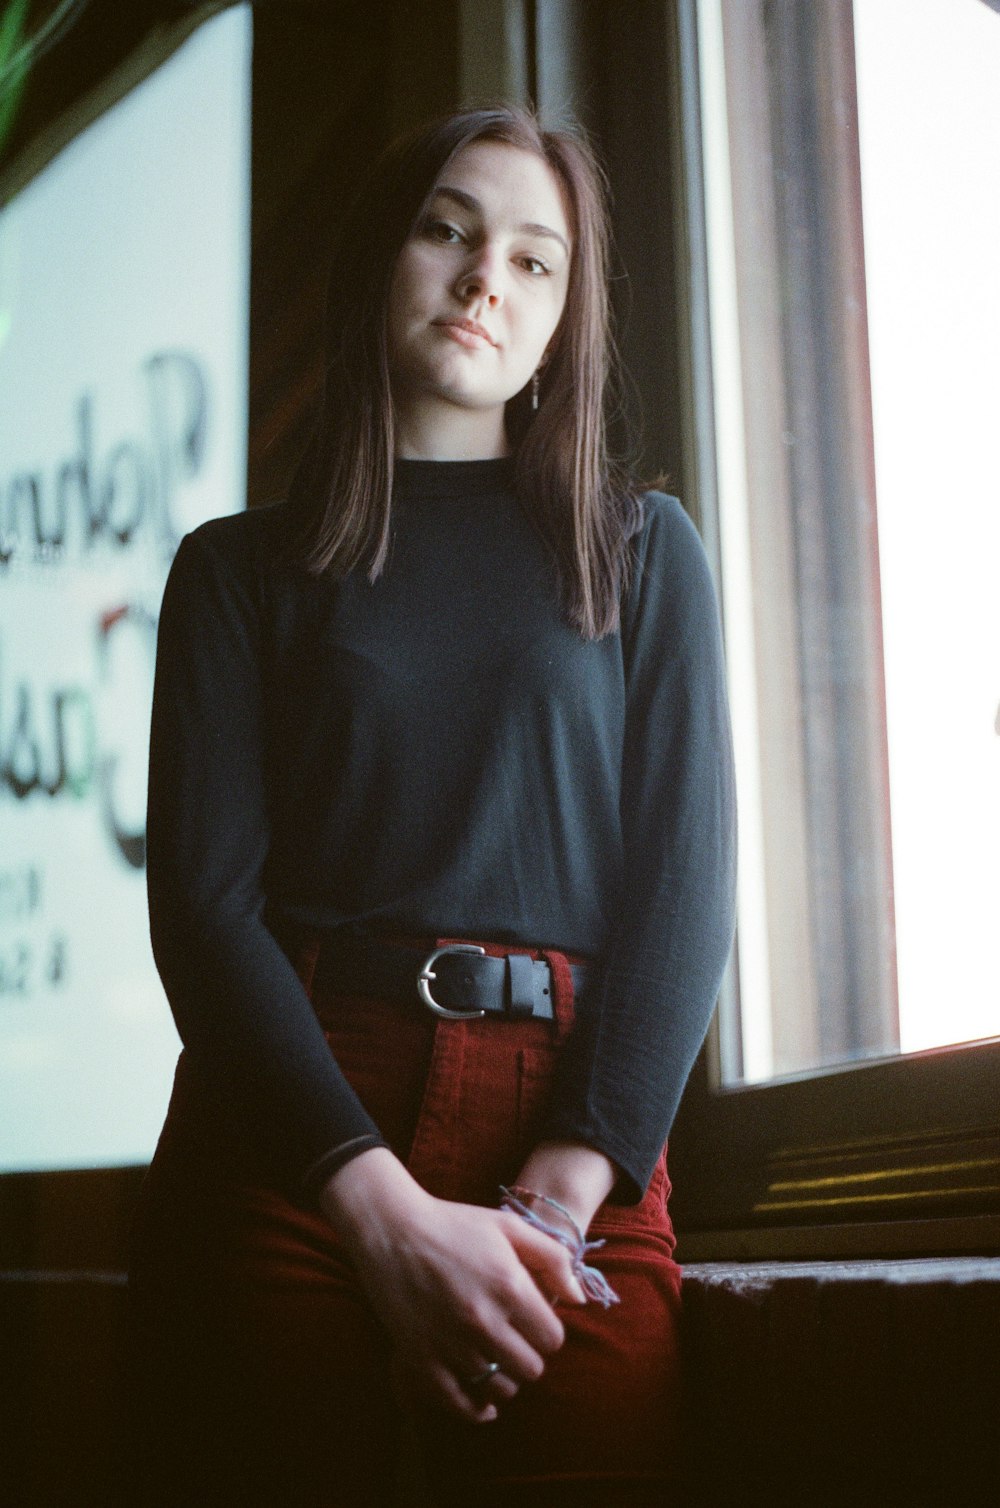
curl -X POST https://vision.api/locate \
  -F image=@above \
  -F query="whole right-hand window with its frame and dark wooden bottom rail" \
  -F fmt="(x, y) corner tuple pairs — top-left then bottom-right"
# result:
(673, 0), (1000, 1256)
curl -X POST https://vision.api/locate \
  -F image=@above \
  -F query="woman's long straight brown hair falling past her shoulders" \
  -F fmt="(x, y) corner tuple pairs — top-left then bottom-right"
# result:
(288, 106), (641, 638)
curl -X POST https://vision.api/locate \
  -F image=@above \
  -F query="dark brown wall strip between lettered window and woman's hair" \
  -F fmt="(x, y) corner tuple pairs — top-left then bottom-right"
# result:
(247, 0), (459, 504)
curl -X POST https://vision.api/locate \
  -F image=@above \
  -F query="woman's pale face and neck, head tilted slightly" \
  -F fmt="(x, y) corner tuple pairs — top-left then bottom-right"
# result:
(388, 142), (572, 458)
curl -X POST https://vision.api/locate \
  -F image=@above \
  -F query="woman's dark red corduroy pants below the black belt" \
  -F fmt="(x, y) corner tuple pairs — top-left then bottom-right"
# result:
(128, 935), (680, 1508)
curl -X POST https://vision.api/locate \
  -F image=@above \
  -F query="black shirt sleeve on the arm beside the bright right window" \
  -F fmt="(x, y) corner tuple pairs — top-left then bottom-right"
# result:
(543, 493), (736, 1202)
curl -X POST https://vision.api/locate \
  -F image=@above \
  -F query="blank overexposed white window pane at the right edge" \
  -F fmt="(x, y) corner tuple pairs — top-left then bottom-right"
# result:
(854, 0), (1000, 1051)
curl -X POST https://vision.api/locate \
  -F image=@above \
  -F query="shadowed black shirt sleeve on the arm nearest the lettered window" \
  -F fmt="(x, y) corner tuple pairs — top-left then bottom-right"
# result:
(146, 520), (383, 1194)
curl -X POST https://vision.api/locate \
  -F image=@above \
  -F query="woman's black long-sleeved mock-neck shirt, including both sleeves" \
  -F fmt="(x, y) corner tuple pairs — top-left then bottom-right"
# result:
(148, 460), (735, 1199)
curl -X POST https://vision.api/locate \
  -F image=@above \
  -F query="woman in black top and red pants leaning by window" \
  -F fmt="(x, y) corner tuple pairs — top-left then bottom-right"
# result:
(133, 110), (733, 1508)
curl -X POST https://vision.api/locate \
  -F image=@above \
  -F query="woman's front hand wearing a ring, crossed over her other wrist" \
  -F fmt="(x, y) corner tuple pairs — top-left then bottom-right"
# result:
(321, 1148), (585, 1422)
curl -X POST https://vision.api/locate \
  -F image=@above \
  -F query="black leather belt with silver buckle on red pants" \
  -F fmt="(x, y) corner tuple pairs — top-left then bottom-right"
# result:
(315, 933), (590, 1021)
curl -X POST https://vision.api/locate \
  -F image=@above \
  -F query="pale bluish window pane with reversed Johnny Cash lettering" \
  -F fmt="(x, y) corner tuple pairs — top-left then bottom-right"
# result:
(0, 6), (250, 1170)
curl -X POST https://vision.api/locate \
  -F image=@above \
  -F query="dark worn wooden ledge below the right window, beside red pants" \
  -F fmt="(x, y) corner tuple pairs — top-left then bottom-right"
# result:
(682, 1258), (1000, 1508)
